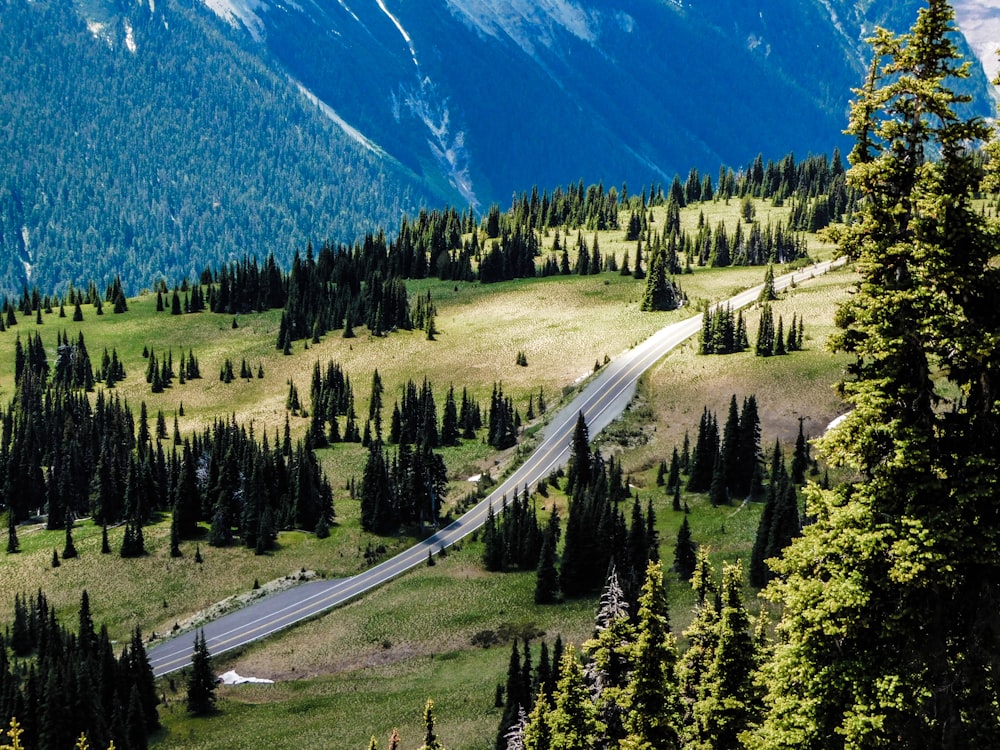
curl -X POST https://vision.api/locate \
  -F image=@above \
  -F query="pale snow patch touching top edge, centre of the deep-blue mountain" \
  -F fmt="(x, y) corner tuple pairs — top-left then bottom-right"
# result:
(446, 0), (596, 57)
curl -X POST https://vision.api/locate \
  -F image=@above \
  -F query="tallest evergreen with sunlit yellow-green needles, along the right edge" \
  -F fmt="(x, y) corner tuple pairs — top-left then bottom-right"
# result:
(752, 0), (1000, 748)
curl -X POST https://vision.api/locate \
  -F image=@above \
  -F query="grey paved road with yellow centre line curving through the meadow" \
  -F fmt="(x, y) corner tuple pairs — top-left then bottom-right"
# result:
(148, 259), (844, 677)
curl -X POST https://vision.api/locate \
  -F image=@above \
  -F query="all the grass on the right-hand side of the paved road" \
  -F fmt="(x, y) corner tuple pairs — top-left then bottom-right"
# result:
(150, 262), (852, 750)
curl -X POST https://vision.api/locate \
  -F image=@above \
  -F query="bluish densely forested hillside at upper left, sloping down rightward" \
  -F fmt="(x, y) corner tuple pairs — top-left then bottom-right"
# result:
(0, 0), (443, 300)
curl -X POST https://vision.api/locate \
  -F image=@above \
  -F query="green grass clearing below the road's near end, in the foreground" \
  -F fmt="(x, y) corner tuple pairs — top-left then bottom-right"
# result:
(157, 544), (593, 749)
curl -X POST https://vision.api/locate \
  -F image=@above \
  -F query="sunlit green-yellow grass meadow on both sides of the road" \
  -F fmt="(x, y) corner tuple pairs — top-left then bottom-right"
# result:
(0, 200), (853, 750)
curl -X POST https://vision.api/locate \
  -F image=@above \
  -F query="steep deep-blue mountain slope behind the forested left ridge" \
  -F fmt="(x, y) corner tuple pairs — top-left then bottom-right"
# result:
(215, 0), (989, 205)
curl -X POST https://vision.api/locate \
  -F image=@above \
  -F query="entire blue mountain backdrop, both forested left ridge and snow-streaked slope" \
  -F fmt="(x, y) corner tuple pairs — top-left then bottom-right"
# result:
(0, 0), (993, 291)
